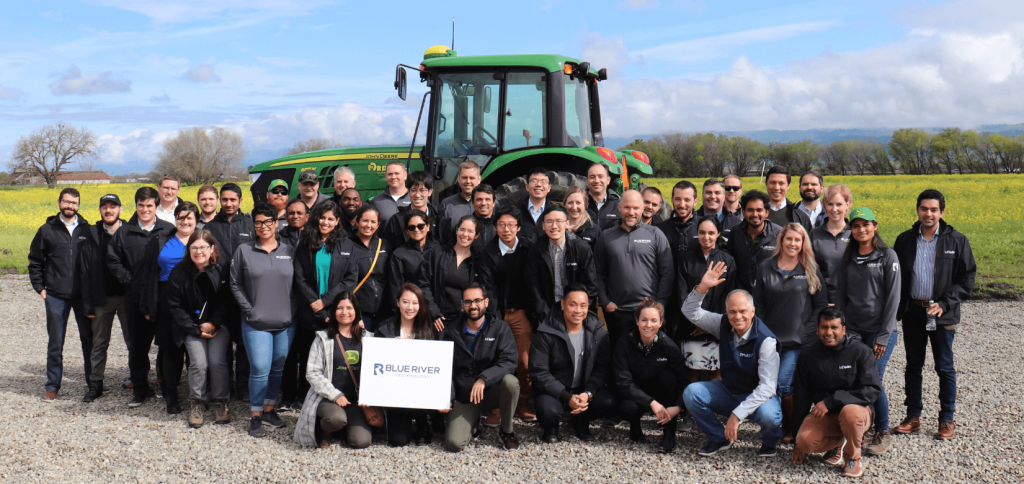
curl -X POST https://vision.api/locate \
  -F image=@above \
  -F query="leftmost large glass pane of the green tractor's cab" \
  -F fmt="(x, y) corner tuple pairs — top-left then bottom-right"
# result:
(434, 73), (501, 158)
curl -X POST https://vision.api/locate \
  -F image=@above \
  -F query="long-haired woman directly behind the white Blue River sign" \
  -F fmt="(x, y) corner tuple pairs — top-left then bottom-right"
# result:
(374, 283), (437, 447)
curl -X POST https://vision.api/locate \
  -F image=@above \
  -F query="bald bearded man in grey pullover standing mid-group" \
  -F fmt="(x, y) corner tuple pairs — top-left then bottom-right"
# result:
(594, 189), (675, 347)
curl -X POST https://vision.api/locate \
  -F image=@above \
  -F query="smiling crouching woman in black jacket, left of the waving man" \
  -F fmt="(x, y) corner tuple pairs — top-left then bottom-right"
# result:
(611, 298), (689, 453)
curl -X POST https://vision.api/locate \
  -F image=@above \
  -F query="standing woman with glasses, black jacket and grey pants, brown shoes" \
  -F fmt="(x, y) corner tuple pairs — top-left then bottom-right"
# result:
(165, 230), (231, 429)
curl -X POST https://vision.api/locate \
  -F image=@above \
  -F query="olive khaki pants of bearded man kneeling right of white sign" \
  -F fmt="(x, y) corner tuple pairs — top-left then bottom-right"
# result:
(444, 375), (519, 452)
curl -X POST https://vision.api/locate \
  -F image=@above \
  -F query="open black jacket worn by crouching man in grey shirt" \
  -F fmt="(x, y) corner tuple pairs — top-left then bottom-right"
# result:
(529, 309), (611, 404)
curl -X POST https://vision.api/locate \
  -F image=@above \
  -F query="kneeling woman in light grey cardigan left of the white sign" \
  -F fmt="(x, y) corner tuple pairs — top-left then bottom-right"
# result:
(295, 291), (373, 448)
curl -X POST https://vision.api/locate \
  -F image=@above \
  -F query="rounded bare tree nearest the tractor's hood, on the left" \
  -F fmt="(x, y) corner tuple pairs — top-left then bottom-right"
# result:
(156, 126), (246, 184)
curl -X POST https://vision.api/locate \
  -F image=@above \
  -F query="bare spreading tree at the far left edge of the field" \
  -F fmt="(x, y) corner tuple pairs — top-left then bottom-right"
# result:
(10, 122), (98, 188)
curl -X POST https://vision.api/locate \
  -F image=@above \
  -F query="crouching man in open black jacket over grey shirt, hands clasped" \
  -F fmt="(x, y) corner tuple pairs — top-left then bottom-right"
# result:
(529, 283), (615, 443)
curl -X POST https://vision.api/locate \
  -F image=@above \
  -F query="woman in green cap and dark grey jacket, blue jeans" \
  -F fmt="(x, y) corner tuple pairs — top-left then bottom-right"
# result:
(836, 207), (901, 455)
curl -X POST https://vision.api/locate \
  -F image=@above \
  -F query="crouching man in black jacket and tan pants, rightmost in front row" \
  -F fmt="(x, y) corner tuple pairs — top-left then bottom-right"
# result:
(793, 307), (882, 477)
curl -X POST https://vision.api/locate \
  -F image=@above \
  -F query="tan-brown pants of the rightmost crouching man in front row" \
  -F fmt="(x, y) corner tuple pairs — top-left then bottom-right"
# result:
(794, 405), (871, 460)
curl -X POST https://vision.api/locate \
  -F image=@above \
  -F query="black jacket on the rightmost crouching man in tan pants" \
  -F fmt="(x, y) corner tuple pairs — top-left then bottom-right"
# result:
(793, 337), (882, 435)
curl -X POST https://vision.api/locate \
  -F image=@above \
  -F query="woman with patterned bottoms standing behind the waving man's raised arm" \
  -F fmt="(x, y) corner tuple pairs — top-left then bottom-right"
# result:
(676, 215), (736, 382)
